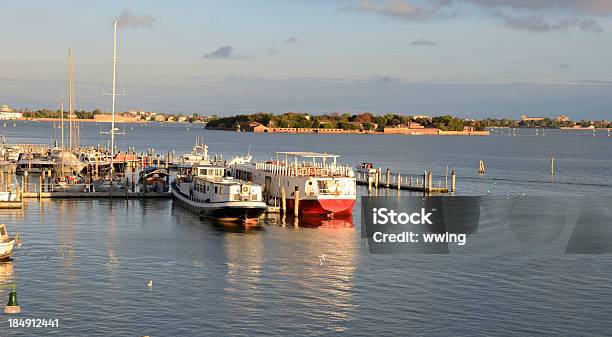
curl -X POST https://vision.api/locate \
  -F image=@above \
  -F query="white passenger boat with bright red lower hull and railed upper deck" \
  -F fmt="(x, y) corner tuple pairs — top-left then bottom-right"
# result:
(228, 152), (356, 215)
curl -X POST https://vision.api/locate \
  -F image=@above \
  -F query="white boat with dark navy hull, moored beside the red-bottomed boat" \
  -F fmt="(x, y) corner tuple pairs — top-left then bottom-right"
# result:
(171, 164), (267, 223)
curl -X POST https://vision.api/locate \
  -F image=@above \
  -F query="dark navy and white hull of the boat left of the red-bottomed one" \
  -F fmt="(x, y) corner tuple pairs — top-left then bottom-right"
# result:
(171, 183), (267, 223)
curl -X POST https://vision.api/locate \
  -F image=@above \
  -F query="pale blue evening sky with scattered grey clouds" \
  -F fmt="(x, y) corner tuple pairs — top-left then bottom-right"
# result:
(0, 0), (612, 119)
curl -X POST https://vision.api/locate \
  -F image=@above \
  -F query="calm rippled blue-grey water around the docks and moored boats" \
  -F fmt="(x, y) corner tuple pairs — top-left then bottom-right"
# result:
(0, 122), (612, 336)
